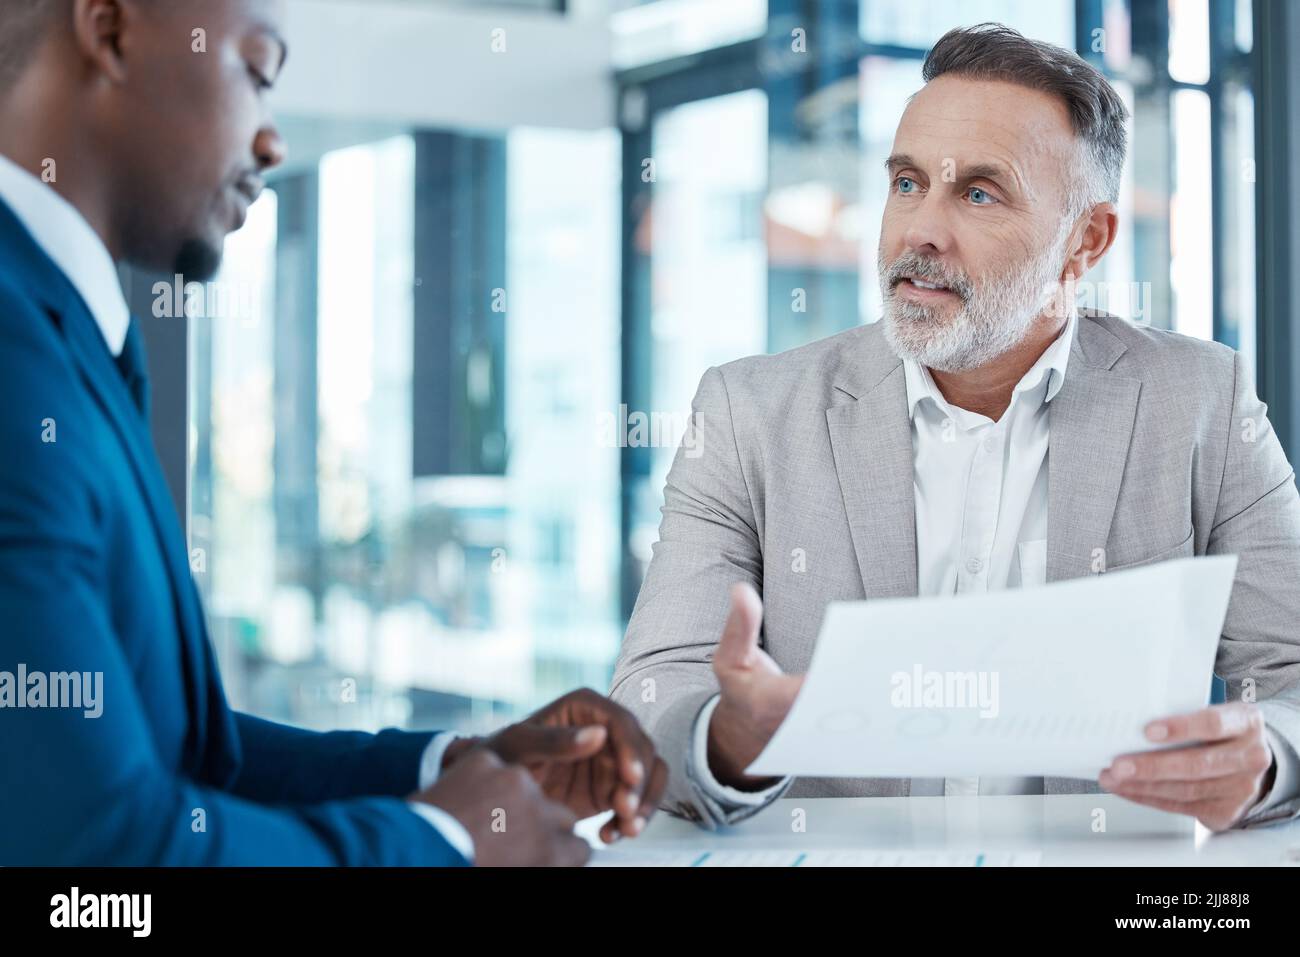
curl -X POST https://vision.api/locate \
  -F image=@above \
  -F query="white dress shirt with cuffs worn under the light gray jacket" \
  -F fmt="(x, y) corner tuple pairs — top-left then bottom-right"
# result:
(688, 313), (1296, 820)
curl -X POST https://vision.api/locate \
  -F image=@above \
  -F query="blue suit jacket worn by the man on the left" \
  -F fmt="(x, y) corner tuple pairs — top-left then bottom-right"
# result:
(0, 203), (464, 865)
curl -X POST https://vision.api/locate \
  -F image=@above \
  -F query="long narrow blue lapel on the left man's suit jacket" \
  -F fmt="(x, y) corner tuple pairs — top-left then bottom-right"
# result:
(0, 203), (239, 785)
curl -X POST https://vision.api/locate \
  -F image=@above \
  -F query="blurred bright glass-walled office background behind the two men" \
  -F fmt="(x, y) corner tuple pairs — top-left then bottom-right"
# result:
(178, 0), (1256, 729)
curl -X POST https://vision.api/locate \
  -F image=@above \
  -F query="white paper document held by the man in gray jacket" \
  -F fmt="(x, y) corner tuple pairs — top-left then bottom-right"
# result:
(748, 555), (1236, 779)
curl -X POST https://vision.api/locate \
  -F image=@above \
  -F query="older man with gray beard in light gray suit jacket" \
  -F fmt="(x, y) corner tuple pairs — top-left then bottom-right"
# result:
(612, 25), (1300, 830)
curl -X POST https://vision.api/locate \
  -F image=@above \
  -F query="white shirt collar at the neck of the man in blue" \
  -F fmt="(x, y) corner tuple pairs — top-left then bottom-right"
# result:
(0, 155), (131, 356)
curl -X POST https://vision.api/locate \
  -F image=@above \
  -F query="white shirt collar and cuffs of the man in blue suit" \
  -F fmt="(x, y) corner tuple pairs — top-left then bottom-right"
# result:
(0, 153), (475, 862)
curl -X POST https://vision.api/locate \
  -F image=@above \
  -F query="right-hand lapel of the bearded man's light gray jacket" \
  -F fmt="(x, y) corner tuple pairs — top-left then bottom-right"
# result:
(1048, 316), (1141, 581)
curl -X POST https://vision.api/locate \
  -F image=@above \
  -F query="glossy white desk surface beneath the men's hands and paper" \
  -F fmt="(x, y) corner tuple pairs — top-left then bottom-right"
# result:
(580, 794), (1300, 867)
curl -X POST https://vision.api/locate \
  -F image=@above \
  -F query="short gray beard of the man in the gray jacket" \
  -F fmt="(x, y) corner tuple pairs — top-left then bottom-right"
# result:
(879, 237), (1063, 372)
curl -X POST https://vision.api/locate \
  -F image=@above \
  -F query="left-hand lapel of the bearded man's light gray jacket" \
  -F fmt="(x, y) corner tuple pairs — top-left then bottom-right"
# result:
(826, 341), (917, 598)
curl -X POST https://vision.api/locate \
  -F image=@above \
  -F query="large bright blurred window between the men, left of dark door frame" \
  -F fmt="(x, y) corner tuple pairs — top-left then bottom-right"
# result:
(191, 129), (621, 727)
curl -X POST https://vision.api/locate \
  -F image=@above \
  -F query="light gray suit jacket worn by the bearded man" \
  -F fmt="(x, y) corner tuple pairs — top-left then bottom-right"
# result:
(611, 311), (1300, 824)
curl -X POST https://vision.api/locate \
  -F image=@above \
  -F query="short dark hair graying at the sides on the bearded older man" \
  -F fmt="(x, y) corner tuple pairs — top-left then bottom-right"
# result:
(920, 23), (1128, 213)
